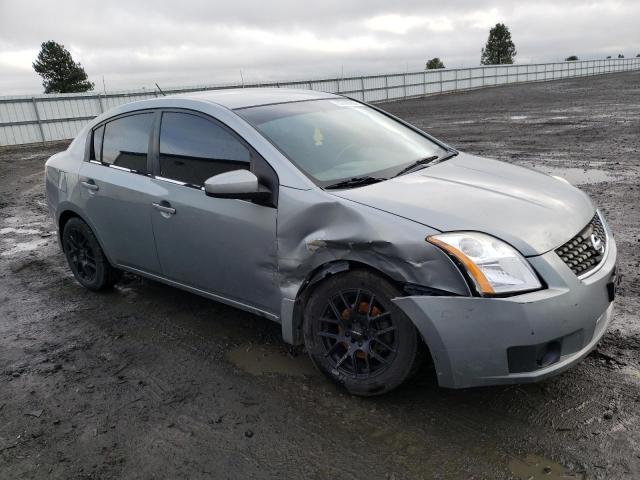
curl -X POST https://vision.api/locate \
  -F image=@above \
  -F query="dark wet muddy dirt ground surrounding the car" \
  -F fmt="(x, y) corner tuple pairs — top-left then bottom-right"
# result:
(0, 72), (640, 480)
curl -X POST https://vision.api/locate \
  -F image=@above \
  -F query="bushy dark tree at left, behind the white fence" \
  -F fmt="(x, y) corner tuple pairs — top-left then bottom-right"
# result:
(33, 40), (94, 93)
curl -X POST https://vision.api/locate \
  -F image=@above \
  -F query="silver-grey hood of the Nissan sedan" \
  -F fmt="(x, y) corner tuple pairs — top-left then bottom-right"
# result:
(332, 153), (595, 256)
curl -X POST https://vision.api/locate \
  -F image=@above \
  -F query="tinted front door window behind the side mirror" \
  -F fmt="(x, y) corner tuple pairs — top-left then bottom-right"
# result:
(160, 112), (251, 187)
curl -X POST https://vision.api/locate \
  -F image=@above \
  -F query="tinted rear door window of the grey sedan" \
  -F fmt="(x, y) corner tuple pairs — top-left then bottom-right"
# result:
(101, 113), (153, 173)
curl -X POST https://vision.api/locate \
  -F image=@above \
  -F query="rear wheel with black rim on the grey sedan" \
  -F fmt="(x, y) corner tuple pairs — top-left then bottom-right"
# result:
(62, 217), (122, 291)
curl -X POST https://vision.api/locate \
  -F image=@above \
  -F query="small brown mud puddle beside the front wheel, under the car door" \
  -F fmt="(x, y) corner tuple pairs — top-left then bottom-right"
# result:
(226, 345), (318, 377)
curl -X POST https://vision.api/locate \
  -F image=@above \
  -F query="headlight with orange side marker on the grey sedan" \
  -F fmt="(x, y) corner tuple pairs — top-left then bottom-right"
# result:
(427, 232), (542, 295)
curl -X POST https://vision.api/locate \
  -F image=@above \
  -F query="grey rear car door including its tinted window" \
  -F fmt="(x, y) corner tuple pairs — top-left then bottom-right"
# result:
(80, 111), (161, 274)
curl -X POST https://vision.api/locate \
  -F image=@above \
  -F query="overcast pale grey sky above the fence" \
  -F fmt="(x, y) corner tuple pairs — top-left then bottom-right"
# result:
(0, 0), (640, 95)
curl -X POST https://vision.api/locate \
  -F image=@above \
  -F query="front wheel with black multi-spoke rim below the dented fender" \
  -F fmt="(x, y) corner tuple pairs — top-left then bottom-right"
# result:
(304, 270), (424, 396)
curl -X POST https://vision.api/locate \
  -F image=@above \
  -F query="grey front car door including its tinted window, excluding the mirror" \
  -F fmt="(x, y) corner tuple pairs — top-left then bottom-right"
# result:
(152, 110), (280, 313)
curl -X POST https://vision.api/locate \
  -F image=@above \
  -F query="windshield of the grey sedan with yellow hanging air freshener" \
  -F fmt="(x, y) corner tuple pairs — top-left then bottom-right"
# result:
(236, 99), (448, 186)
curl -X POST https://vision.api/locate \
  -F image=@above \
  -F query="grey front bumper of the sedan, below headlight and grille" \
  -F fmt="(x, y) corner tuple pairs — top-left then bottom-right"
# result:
(393, 236), (617, 388)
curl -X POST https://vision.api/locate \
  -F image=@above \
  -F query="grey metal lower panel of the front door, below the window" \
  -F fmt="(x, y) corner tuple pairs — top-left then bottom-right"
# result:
(152, 179), (280, 316)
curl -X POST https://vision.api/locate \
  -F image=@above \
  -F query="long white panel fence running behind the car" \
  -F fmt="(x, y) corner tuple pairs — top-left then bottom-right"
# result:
(0, 58), (640, 145)
